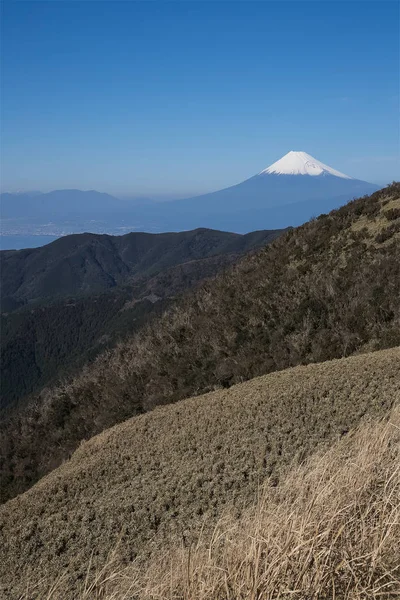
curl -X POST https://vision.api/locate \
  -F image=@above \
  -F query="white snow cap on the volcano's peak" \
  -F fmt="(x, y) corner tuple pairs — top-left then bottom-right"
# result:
(260, 150), (353, 179)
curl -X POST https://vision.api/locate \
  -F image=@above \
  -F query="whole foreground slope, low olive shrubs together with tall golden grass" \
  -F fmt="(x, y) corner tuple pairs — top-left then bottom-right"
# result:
(0, 348), (400, 600)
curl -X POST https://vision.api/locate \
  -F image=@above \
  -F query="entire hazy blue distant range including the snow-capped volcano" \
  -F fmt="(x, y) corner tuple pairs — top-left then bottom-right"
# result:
(1, 151), (378, 233)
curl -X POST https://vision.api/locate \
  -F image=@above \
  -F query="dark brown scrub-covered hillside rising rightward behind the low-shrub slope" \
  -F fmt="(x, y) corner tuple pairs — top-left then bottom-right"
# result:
(1, 183), (400, 498)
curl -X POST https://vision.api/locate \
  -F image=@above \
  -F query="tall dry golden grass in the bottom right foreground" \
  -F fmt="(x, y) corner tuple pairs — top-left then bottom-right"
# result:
(15, 398), (400, 600)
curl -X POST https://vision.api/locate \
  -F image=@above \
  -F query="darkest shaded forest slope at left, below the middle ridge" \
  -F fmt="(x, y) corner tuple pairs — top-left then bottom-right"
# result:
(0, 286), (167, 411)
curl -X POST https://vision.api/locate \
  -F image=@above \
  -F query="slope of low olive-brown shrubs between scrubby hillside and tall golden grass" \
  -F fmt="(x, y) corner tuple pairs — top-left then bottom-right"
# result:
(0, 348), (400, 599)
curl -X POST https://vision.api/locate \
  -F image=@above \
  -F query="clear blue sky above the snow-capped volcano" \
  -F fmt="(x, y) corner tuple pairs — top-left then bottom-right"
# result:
(2, 0), (400, 196)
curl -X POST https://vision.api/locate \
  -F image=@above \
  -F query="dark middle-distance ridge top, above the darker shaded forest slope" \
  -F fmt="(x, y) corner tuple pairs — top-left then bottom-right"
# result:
(0, 229), (281, 310)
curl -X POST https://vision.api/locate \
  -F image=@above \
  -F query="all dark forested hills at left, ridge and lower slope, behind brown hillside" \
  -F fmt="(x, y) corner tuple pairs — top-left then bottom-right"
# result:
(0, 229), (280, 410)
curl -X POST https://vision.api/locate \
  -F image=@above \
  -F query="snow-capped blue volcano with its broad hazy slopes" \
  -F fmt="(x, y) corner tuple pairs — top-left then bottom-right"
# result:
(152, 151), (379, 233)
